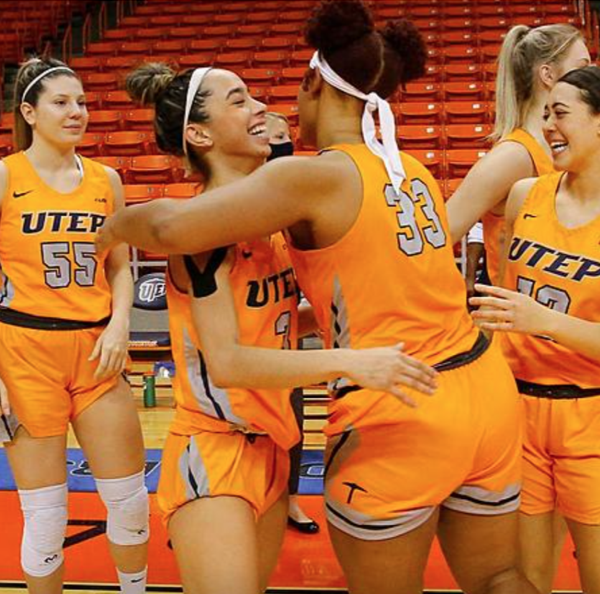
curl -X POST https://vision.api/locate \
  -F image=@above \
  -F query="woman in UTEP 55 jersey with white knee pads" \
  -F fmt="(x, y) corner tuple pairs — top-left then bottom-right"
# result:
(0, 59), (148, 594)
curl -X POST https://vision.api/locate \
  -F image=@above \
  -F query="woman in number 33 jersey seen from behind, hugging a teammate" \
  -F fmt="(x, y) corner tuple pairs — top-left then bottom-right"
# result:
(99, 0), (535, 594)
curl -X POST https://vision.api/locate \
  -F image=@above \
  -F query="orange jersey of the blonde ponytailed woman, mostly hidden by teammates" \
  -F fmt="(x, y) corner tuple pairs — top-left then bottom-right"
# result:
(482, 128), (554, 285)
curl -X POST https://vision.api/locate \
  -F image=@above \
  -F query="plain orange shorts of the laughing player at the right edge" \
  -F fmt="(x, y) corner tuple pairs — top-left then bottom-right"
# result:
(521, 396), (600, 524)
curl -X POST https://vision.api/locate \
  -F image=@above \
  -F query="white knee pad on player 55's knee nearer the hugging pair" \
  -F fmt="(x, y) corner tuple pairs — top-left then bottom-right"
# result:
(96, 471), (150, 546)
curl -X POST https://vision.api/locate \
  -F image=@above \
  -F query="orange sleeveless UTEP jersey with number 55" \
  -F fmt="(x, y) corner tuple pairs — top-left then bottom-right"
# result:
(0, 152), (114, 322)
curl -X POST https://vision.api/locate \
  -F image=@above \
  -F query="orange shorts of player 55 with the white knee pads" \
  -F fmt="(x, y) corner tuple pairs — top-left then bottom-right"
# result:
(0, 323), (119, 437)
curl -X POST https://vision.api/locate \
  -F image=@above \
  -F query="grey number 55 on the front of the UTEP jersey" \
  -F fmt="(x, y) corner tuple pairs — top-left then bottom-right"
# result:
(42, 241), (98, 289)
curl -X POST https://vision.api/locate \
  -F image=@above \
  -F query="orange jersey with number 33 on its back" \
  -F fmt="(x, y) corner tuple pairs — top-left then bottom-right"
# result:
(290, 145), (478, 428)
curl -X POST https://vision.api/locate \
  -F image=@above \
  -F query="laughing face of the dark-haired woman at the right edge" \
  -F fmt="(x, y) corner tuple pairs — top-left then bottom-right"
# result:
(544, 82), (600, 173)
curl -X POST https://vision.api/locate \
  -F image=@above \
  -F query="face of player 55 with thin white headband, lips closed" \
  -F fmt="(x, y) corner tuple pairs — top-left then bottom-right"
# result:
(21, 75), (89, 147)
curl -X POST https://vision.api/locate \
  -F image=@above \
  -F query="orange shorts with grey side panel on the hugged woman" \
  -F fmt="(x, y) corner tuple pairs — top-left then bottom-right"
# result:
(158, 431), (290, 524)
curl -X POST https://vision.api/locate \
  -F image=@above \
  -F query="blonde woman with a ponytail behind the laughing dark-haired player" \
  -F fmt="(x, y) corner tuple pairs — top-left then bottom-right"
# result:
(447, 25), (590, 285)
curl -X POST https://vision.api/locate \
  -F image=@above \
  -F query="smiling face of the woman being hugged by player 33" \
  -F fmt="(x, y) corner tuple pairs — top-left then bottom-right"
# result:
(186, 69), (271, 160)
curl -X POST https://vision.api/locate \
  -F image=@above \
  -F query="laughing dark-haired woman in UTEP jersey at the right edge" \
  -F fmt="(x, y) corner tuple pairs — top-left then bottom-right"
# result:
(471, 67), (600, 594)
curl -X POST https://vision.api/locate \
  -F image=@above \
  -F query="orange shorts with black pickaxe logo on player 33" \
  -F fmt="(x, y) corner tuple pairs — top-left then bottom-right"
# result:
(325, 345), (522, 540)
